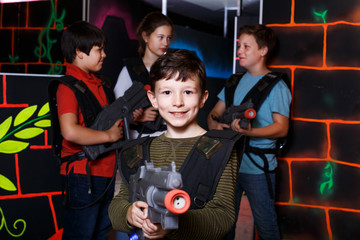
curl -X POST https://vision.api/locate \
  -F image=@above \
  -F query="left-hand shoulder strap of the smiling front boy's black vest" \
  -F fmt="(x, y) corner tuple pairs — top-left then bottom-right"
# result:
(116, 137), (154, 187)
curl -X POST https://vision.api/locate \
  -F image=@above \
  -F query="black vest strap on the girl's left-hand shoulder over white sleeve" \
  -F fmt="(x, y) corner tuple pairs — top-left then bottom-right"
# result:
(124, 58), (150, 85)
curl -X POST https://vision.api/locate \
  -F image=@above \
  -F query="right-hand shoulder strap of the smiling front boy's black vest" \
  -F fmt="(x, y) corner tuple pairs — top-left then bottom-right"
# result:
(180, 130), (243, 209)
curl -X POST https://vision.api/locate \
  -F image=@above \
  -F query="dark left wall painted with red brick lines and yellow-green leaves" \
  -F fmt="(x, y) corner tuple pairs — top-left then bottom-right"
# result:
(0, 0), (82, 240)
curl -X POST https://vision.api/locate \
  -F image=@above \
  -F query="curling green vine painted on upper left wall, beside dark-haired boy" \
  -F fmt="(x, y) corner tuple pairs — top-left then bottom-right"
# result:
(34, 0), (65, 74)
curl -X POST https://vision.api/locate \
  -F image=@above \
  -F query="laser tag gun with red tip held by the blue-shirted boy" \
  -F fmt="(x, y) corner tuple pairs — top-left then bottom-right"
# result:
(211, 99), (256, 129)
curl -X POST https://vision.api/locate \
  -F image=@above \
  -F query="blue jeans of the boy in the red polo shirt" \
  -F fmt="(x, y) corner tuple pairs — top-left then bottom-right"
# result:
(62, 172), (115, 240)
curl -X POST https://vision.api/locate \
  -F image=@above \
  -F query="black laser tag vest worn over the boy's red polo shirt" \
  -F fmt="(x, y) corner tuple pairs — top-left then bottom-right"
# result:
(48, 75), (115, 163)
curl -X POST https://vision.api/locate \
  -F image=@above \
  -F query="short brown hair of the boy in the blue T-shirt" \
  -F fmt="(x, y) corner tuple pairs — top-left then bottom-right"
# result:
(238, 24), (277, 60)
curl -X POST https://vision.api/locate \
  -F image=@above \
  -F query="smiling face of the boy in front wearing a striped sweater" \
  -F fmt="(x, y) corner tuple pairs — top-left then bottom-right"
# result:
(148, 73), (208, 137)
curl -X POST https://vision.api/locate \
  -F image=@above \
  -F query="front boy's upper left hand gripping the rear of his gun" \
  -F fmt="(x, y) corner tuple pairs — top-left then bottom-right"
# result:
(126, 201), (149, 228)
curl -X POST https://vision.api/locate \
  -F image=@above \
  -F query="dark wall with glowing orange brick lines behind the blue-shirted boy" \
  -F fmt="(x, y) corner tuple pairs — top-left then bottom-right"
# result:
(264, 0), (360, 240)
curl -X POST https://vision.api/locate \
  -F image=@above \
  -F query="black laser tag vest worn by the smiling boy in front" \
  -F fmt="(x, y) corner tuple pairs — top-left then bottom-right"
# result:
(117, 130), (244, 209)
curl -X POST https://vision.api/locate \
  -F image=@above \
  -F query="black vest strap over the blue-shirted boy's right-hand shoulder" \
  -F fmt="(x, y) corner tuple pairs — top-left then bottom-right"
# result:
(242, 72), (287, 111)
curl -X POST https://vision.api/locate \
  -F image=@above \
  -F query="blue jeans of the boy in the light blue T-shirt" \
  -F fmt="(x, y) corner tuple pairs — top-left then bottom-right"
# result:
(226, 173), (280, 240)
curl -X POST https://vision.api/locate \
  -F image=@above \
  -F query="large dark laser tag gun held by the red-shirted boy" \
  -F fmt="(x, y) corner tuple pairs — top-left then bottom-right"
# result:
(83, 81), (160, 160)
